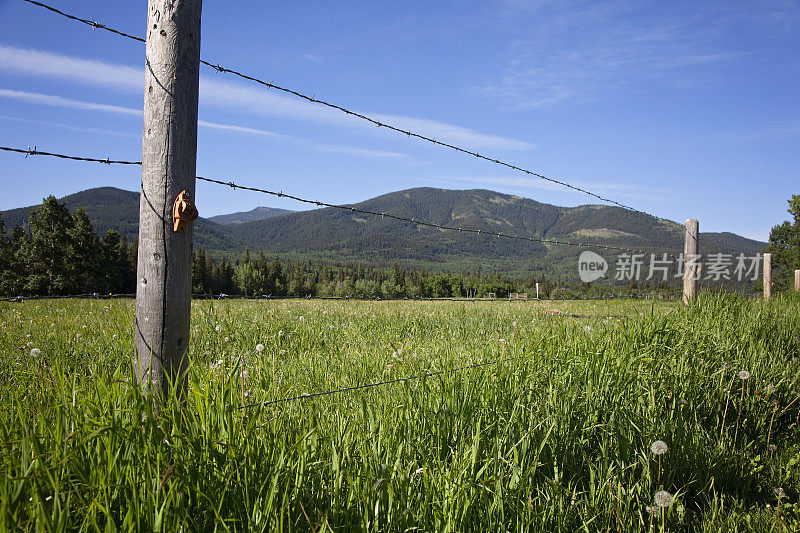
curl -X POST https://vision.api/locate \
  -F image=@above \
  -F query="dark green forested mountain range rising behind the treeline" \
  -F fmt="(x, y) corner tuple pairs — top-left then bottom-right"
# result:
(2, 187), (765, 274)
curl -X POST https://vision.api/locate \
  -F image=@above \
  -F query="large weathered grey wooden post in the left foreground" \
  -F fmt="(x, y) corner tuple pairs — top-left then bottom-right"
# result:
(134, 0), (202, 397)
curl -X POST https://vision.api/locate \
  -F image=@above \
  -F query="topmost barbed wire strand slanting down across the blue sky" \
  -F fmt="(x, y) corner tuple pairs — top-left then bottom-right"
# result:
(23, 0), (658, 212)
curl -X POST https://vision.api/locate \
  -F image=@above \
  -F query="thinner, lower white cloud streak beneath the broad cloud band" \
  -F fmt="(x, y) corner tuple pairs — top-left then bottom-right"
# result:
(0, 85), (410, 159)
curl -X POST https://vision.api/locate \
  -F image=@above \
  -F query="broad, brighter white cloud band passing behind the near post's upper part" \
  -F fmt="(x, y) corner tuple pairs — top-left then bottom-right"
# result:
(0, 45), (535, 150)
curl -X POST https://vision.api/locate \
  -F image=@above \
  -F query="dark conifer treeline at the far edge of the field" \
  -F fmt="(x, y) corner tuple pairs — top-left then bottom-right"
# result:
(0, 196), (676, 298)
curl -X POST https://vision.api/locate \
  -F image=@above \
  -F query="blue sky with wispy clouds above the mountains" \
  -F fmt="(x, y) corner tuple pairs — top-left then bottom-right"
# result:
(0, 0), (800, 240)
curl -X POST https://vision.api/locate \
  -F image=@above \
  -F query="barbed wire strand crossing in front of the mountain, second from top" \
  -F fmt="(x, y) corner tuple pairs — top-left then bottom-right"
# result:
(0, 146), (676, 253)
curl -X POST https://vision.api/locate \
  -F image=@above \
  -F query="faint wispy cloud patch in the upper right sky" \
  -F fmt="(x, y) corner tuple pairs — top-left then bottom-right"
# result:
(474, 0), (800, 109)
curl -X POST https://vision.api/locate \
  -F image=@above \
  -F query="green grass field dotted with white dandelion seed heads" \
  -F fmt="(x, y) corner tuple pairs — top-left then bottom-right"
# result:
(0, 295), (800, 532)
